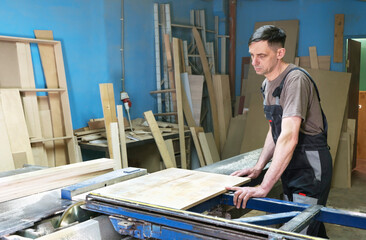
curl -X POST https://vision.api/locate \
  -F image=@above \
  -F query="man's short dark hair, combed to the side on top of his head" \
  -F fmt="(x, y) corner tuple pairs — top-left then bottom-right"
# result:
(248, 25), (286, 47)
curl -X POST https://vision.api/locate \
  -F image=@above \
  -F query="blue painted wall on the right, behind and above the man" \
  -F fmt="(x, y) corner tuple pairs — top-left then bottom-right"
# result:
(236, 0), (366, 95)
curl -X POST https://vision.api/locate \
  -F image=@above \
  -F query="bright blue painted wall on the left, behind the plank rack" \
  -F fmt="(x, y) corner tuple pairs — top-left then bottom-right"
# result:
(0, 0), (214, 129)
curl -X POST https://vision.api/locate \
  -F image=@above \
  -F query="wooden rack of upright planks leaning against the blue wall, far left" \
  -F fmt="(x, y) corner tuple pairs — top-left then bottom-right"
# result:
(0, 31), (80, 170)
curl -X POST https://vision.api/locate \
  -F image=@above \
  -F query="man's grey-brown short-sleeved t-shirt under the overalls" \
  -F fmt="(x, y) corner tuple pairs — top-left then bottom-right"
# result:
(262, 64), (324, 135)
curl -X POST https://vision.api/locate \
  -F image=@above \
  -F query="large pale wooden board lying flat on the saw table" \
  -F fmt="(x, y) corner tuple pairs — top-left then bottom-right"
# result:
(92, 168), (249, 210)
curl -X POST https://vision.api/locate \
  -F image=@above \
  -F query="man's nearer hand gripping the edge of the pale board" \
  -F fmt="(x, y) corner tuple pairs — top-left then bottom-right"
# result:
(226, 185), (268, 208)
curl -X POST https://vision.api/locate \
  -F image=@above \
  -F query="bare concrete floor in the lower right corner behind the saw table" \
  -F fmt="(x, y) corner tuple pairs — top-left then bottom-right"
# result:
(325, 159), (366, 240)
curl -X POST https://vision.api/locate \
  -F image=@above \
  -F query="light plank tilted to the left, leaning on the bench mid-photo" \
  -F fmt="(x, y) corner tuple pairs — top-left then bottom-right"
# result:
(144, 111), (177, 168)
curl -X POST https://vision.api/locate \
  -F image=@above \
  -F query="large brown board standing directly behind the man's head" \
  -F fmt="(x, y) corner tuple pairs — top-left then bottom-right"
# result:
(242, 20), (299, 107)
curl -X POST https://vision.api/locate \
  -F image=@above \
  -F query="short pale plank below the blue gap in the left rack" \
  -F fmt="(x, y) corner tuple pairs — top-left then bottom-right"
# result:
(37, 96), (56, 167)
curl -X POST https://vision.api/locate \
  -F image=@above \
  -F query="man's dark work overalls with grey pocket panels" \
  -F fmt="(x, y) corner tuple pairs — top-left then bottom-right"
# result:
(261, 68), (332, 237)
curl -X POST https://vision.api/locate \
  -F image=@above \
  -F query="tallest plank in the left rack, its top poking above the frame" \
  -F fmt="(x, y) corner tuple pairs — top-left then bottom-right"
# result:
(34, 30), (68, 166)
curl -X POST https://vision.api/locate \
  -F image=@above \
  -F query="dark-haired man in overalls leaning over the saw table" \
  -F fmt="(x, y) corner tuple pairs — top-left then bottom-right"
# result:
(227, 25), (332, 237)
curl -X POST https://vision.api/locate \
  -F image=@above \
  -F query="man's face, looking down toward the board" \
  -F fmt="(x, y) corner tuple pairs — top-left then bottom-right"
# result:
(249, 41), (282, 76)
